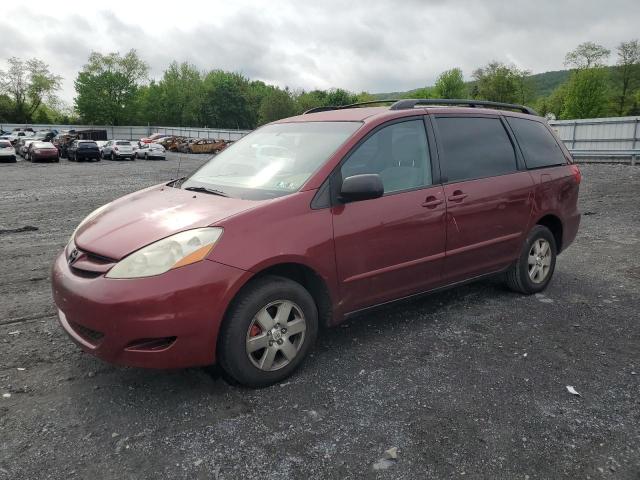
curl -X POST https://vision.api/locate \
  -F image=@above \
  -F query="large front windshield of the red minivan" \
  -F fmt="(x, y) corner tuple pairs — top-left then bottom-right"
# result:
(180, 122), (362, 200)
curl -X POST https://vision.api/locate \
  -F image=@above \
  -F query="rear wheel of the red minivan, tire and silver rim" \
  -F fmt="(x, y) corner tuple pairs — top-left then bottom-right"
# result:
(505, 225), (558, 295)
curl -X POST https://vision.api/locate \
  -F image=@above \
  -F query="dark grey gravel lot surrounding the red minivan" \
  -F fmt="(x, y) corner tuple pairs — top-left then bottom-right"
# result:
(0, 156), (640, 479)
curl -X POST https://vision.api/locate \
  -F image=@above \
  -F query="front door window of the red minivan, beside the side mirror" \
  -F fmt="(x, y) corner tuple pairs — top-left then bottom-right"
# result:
(341, 120), (432, 193)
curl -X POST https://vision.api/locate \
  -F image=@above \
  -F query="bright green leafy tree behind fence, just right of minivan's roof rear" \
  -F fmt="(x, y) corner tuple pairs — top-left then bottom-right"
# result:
(561, 68), (607, 119)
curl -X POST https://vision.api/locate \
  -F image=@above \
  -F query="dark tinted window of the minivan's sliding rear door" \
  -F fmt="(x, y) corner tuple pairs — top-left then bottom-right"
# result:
(436, 117), (517, 182)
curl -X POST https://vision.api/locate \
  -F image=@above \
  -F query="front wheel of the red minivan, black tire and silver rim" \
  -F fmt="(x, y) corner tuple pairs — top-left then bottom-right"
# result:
(218, 275), (318, 388)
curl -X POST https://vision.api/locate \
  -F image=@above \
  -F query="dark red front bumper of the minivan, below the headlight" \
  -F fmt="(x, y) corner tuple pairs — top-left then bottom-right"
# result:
(52, 252), (250, 368)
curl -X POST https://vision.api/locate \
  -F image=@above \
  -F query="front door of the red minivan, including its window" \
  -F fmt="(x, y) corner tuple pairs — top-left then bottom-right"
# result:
(332, 118), (445, 312)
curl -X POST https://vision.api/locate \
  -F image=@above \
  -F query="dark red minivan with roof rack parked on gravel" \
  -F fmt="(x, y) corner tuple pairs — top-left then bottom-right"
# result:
(52, 100), (581, 386)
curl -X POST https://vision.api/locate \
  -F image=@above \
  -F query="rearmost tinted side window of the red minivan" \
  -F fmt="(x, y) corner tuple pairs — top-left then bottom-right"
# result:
(507, 117), (567, 168)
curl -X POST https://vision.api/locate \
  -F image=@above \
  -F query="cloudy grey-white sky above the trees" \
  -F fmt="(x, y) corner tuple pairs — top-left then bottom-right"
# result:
(0, 0), (640, 102)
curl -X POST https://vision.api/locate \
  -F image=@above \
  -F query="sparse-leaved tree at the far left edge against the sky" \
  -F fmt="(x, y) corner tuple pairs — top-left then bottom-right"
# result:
(0, 57), (62, 123)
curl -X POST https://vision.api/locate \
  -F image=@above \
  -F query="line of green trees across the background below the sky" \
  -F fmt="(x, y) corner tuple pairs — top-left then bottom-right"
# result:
(0, 40), (640, 129)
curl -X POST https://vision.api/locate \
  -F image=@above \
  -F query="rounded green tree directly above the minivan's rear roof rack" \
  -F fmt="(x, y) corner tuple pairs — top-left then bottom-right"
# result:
(473, 61), (528, 103)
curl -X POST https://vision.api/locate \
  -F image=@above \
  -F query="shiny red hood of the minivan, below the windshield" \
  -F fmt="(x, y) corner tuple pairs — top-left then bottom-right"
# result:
(74, 184), (263, 260)
